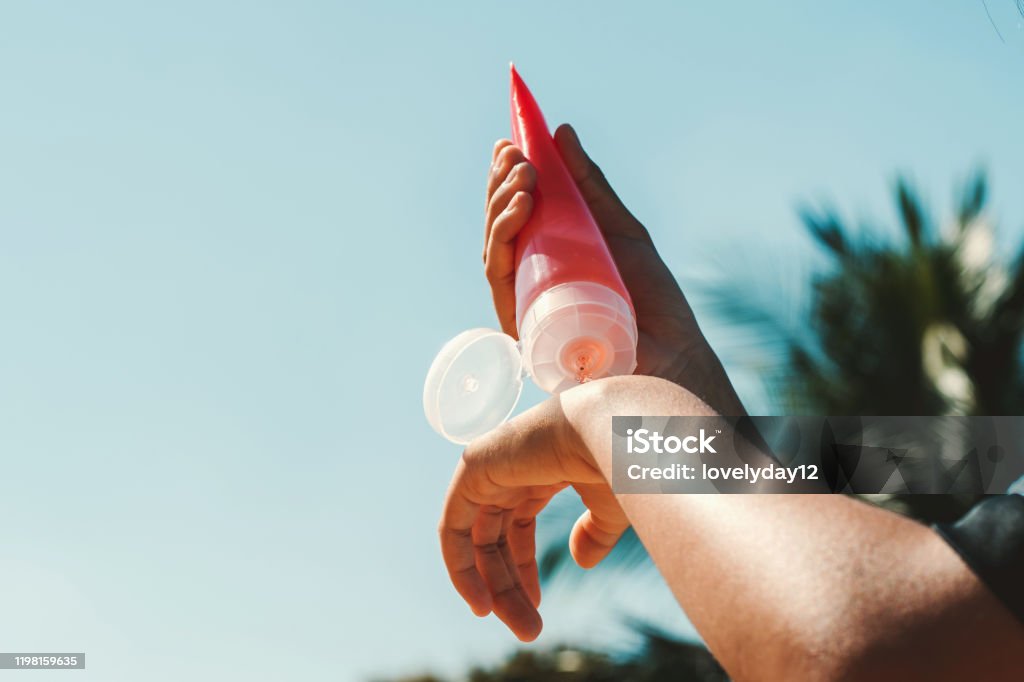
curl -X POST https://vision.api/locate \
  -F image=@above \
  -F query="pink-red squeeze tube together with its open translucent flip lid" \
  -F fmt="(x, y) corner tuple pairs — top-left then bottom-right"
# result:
(423, 67), (637, 443)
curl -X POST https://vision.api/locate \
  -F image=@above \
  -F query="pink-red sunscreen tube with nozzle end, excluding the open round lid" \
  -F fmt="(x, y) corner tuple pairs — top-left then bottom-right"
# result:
(511, 66), (637, 393)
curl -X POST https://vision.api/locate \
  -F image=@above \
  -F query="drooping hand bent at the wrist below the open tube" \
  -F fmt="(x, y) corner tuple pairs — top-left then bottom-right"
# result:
(438, 382), (629, 641)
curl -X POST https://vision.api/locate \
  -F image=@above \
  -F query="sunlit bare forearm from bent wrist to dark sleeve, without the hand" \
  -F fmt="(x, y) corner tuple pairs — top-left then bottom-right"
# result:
(563, 377), (1022, 680)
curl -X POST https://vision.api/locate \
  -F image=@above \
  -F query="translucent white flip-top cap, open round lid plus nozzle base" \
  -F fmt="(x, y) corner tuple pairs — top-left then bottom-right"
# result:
(423, 282), (637, 444)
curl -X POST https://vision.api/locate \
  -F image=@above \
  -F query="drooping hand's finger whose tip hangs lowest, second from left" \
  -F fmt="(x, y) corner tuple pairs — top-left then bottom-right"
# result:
(473, 506), (542, 641)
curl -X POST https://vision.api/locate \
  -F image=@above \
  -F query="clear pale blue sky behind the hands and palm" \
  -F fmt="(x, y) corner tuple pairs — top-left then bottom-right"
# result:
(0, 0), (1024, 682)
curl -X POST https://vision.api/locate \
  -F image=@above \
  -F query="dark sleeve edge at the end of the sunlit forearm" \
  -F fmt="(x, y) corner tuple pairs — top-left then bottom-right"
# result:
(935, 495), (1024, 623)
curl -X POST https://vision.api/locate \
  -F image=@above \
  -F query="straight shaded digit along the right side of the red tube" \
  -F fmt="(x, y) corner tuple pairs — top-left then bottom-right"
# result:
(554, 123), (650, 241)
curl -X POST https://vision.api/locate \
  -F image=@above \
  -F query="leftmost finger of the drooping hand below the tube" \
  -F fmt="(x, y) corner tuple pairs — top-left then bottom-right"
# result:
(438, 463), (493, 616)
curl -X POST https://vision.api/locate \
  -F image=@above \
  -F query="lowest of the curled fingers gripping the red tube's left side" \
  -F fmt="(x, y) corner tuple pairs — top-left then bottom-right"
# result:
(483, 191), (534, 339)
